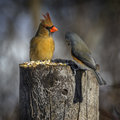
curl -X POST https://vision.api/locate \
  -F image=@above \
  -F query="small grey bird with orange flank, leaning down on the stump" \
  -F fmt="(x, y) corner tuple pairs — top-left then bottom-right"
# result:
(65, 32), (106, 85)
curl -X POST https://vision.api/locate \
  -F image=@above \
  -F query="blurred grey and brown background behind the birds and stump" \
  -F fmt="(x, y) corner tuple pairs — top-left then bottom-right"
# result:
(0, 0), (120, 120)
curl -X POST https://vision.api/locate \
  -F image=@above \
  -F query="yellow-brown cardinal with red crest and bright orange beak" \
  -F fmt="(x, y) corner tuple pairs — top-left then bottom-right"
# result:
(30, 13), (58, 61)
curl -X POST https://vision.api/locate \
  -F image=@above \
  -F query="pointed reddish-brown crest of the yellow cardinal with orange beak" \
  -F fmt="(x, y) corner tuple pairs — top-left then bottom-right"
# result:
(41, 12), (53, 27)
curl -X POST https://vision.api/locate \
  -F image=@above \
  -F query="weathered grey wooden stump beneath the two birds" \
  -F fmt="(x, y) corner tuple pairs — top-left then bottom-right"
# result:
(20, 61), (99, 120)
